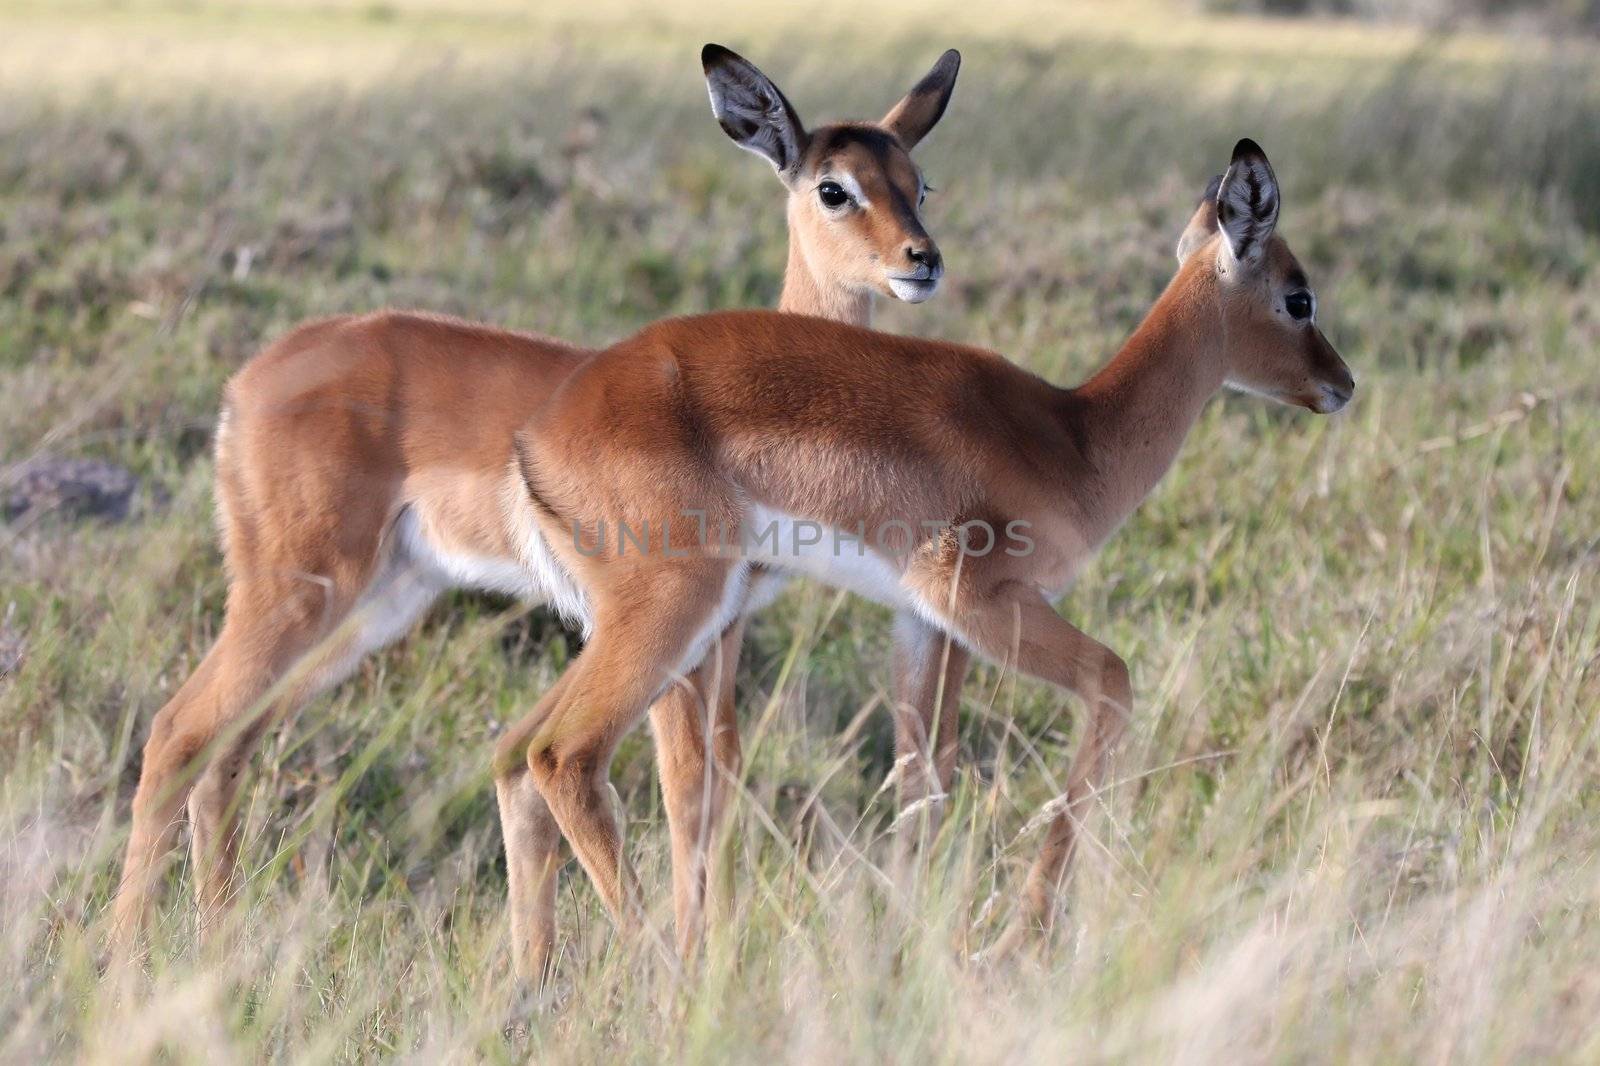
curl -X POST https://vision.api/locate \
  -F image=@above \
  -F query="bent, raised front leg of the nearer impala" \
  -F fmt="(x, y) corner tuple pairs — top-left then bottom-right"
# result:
(915, 581), (1133, 944)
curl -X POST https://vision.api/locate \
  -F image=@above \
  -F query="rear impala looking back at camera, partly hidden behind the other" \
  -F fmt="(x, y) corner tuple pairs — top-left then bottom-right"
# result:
(114, 45), (960, 975)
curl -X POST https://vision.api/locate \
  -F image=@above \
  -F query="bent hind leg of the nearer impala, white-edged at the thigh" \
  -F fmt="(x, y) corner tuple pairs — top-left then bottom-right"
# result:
(502, 560), (742, 953)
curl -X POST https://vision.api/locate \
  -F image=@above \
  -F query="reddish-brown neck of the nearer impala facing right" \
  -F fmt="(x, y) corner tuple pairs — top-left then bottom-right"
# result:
(1069, 271), (1224, 533)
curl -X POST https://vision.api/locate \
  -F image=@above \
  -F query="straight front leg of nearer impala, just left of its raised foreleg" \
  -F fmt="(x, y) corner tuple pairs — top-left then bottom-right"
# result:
(894, 611), (971, 839)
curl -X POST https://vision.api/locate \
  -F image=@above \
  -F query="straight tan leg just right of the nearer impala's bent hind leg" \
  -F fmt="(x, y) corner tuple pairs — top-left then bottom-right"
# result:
(650, 619), (744, 959)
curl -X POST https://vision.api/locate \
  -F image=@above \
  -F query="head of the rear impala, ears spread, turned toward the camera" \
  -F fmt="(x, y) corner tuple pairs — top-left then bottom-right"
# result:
(701, 45), (962, 304)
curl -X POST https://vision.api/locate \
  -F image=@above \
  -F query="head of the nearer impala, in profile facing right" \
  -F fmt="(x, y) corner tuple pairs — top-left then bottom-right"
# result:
(1178, 139), (1355, 415)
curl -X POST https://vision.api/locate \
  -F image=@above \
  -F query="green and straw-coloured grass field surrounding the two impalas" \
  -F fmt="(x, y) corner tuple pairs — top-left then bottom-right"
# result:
(0, 0), (1600, 1063)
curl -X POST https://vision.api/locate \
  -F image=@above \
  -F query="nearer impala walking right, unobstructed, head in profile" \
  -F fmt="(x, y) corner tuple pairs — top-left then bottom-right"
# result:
(496, 141), (1354, 935)
